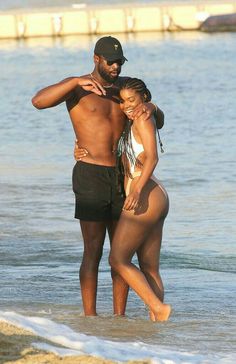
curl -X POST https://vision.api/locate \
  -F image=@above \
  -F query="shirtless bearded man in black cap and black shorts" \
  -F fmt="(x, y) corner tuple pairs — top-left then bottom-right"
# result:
(32, 36), (164, 316)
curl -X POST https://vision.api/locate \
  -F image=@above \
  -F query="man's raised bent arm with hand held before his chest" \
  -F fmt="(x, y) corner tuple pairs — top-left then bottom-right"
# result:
(32, 76), (106, 109)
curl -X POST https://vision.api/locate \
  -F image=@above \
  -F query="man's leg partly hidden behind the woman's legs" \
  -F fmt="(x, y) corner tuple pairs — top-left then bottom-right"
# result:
(107, 221), (129, 316)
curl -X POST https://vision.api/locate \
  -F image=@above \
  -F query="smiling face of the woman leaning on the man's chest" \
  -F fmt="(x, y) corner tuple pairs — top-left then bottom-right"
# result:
(120, 89), (143, 120)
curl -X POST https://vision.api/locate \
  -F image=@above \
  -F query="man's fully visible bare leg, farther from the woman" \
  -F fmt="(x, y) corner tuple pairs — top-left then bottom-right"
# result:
(80, 220), (106, 316)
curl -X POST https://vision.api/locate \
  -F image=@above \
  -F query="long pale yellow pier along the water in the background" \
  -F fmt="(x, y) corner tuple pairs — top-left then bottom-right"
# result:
(0, 0), (236, 39)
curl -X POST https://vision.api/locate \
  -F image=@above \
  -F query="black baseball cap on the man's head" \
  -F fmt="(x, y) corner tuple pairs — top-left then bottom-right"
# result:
(94, 36), (128, 62)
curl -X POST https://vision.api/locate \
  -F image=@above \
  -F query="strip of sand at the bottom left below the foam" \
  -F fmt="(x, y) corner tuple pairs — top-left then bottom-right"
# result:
(0, 321), (151, 364)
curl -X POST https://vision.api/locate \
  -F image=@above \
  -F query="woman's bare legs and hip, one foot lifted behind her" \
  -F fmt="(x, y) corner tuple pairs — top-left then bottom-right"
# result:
(110, 181), (171, 321)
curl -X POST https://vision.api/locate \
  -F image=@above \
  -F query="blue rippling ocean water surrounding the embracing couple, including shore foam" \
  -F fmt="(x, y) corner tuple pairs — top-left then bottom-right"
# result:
(0, 32), (236, 364)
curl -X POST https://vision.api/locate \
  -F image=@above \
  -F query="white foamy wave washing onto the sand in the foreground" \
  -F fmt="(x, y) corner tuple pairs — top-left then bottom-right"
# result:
(0, 311), (236, 364)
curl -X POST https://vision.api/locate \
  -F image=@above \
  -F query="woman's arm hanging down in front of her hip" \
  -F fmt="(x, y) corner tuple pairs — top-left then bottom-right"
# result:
(123, 118), (158, 210)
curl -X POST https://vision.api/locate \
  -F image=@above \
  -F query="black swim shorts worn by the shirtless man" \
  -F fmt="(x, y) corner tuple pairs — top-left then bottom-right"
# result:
(72, 161), (125, 221)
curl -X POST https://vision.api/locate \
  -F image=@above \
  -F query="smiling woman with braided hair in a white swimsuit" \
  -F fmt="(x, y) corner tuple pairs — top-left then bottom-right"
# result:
(109, 78), (171, 321)
